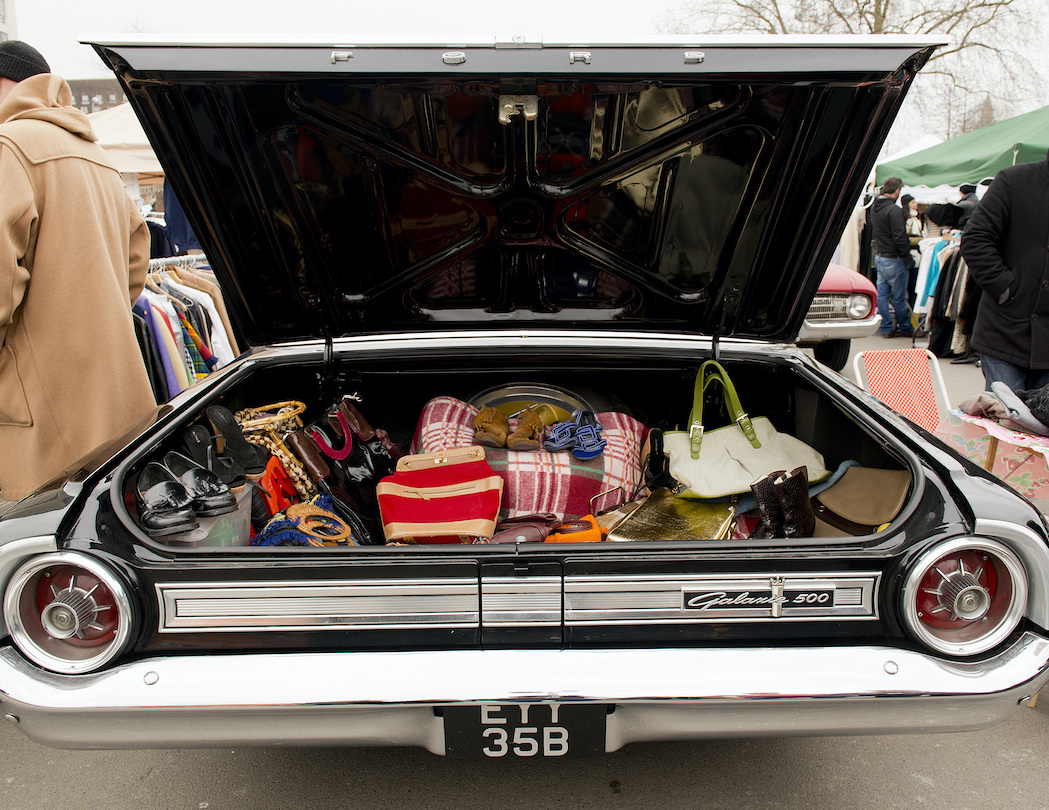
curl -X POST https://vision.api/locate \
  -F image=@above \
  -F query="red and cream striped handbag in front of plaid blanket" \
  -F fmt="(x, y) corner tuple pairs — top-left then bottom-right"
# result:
(376, 445), (502, 543)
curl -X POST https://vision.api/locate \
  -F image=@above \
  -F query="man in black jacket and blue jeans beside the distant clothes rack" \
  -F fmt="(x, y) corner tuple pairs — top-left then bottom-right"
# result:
(871, 177), (917, 338)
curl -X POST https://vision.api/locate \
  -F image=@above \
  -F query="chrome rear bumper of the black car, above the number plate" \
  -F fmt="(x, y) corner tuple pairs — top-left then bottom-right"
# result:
(0, 633), (1049, 753)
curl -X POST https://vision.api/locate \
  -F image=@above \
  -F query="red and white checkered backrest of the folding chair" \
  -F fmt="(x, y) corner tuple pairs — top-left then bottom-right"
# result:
(862, 348), (940, 432)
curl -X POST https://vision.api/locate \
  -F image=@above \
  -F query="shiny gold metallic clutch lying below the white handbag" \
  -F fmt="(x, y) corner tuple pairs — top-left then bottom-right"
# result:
(608, 489), (735, 542)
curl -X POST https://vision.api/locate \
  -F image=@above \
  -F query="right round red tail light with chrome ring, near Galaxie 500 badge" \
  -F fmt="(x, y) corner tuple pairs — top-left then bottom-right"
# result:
(903, 537), (1027, 656)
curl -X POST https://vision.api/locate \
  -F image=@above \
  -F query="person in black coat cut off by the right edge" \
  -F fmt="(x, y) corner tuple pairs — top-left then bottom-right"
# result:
(961, 156), (1049, 390)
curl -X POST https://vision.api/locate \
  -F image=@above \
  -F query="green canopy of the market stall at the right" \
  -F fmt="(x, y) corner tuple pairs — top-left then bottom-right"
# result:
(876, 102), (1049, 187)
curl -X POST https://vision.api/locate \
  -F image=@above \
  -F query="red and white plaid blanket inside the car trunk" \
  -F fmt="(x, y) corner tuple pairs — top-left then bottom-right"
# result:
(411, 397), (648, 520)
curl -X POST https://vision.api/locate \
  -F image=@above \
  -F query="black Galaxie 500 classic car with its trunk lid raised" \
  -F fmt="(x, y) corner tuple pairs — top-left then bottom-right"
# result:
(0, 37), (1049, 758)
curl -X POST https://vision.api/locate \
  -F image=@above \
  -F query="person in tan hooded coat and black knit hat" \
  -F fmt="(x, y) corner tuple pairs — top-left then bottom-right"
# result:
(0, 40), (156, 511)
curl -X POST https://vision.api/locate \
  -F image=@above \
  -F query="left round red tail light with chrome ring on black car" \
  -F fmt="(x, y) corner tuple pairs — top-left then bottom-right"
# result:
(3, 552), (131, 674)
